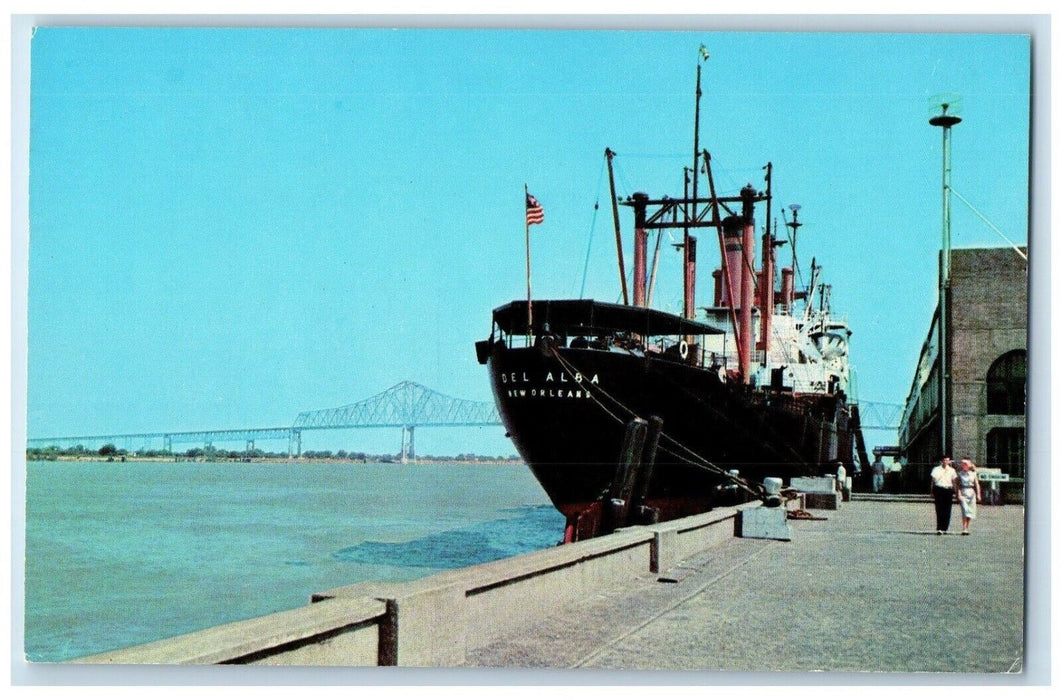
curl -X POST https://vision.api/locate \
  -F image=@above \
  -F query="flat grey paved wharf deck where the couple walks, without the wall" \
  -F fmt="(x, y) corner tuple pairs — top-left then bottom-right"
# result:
(465, 499), (1025, 673)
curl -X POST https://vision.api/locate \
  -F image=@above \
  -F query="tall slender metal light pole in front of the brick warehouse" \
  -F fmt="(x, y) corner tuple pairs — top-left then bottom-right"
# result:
(929, 99), (962, 457)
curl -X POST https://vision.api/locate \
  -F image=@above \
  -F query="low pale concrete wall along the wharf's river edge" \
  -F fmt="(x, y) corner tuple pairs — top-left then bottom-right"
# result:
(78, 506), (747, 667)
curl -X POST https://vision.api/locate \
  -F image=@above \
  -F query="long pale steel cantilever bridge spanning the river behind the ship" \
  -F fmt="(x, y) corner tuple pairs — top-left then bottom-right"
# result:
(27, 381), (903, 460)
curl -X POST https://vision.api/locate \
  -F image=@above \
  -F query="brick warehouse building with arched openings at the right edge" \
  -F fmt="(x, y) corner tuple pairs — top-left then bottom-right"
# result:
(900, 247), (1029, 500)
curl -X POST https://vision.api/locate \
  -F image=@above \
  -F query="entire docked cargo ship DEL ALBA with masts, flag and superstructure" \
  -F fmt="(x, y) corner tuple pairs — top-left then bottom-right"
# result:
(476, 52), (856, 542)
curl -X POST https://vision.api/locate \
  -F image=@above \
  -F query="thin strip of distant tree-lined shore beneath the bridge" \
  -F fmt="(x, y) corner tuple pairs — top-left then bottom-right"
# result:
(25, 443), (519, 462)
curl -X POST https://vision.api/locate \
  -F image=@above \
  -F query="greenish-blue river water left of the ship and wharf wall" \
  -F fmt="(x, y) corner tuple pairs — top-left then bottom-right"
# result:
(25, 462), (564, 662)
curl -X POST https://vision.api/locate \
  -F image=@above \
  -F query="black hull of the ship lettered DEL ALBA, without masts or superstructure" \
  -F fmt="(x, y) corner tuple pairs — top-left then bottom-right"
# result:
(487, 343), (852, 541)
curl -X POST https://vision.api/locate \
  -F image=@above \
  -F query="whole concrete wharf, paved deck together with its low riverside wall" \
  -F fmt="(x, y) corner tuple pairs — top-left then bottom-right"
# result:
(65, 497), (1032, 684)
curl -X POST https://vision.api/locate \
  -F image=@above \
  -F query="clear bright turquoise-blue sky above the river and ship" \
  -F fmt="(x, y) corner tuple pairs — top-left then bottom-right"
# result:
(28, 28), (1030, 454)
